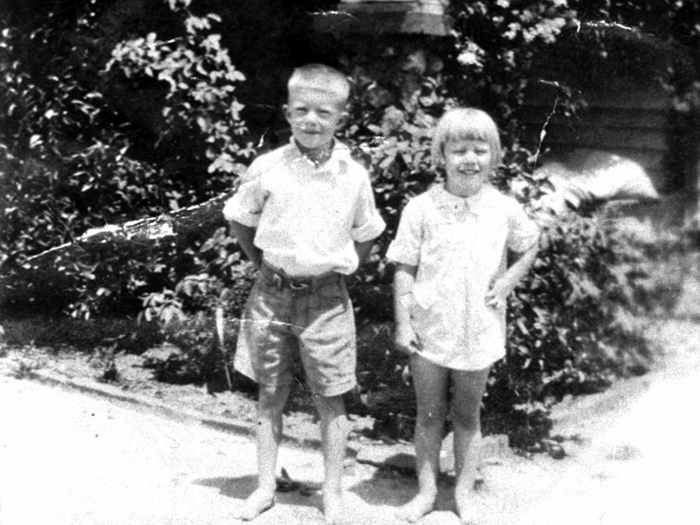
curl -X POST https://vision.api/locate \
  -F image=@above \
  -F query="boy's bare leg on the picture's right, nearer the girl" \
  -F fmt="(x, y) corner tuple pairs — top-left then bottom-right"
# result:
(314, 396), (348, 525)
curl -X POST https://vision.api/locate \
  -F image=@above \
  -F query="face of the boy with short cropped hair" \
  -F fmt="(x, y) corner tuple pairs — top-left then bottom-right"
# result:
(285, 87), (345, 152)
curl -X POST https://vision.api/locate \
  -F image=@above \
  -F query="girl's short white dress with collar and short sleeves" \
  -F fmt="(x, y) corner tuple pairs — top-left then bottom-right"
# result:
(387, 185), (539, 370)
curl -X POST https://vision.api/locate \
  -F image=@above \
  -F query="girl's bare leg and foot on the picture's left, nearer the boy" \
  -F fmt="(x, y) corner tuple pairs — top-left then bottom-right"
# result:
(397, 354), (449, 523)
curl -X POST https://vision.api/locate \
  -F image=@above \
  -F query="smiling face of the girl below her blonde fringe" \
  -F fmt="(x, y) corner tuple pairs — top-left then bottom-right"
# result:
(444, 139), (493, 197)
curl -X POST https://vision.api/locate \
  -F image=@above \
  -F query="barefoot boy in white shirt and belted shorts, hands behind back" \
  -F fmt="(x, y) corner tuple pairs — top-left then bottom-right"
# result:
(224, 64), (385, 524)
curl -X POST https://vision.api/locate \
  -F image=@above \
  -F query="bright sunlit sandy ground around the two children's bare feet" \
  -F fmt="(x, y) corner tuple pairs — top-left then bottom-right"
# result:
(0, 321), (700, 525)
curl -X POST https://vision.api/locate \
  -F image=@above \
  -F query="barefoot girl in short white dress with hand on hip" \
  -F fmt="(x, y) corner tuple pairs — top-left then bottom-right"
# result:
(387, 108), (539, 523)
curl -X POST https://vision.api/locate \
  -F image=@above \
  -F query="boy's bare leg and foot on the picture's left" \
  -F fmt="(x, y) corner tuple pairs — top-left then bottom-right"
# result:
(236, 385), (290, 521)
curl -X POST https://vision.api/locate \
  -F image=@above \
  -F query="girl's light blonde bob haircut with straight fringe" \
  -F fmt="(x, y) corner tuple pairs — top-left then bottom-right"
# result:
(432, 108), (503, 170)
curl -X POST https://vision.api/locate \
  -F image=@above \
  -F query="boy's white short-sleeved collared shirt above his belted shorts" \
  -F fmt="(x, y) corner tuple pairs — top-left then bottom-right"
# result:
(224, 139), (385, 277)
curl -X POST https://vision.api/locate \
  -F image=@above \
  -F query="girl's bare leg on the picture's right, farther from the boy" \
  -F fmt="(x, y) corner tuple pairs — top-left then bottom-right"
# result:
(452, 367), (490, 525)
